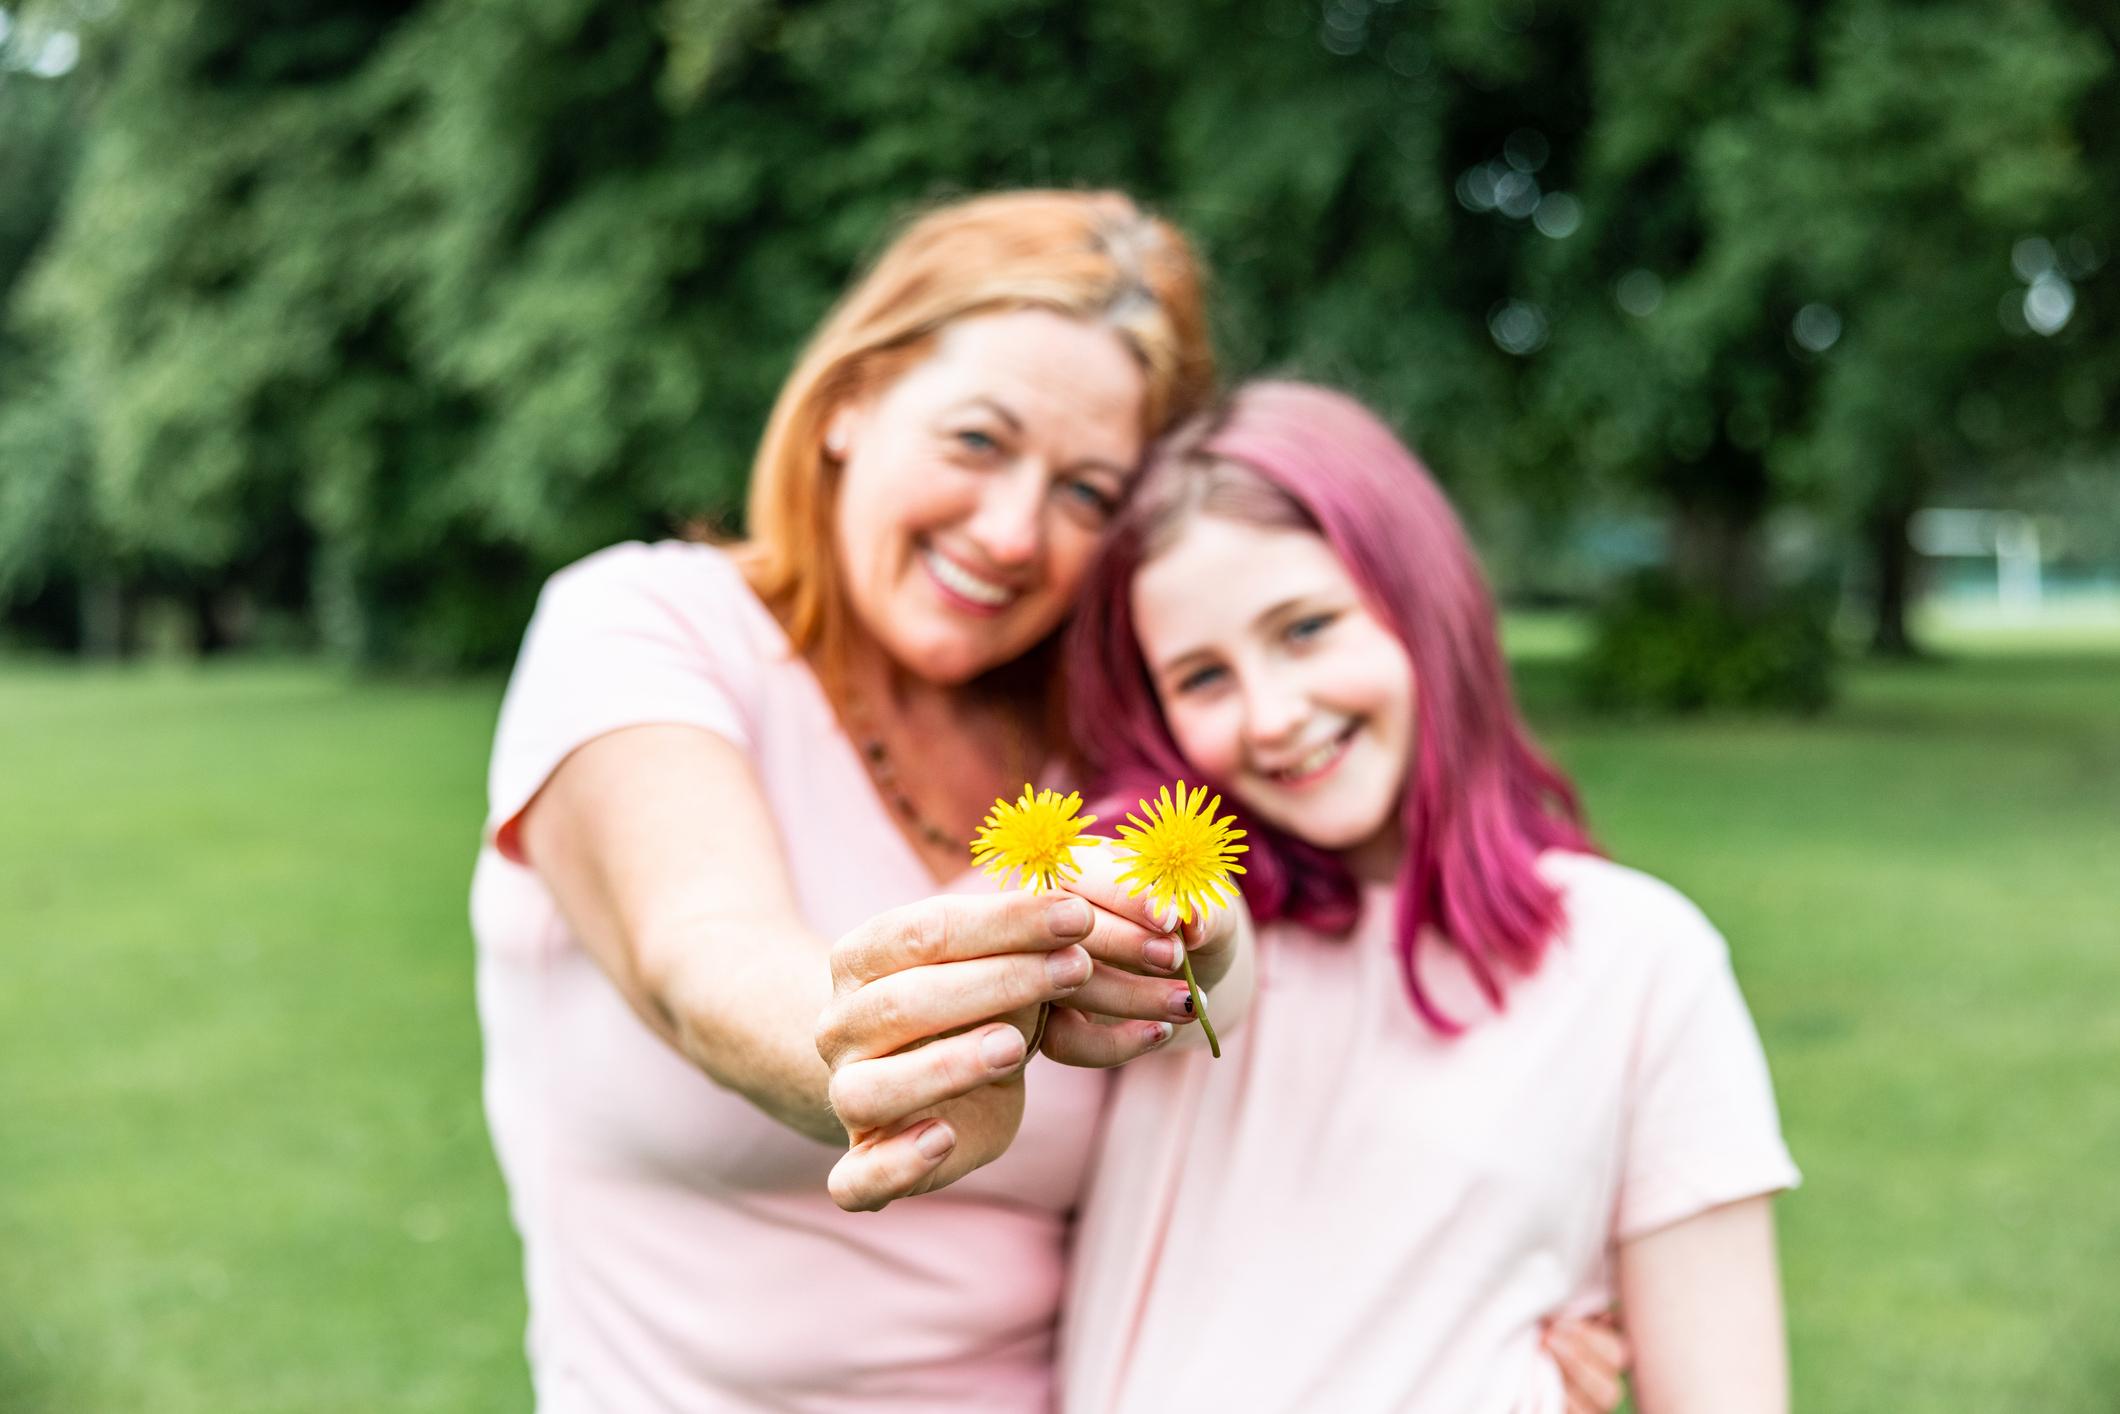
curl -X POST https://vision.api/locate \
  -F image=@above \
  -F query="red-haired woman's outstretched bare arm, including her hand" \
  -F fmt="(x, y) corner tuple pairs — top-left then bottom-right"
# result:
(522, 725), (1178, 1206)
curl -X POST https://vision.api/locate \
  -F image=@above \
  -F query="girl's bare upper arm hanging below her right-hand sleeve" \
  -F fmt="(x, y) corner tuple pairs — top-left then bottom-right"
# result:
(1620, 1198), (1789, 1414)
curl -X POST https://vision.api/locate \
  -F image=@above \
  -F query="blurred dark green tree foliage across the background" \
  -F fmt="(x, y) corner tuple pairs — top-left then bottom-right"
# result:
(0, 0), (2120, 686)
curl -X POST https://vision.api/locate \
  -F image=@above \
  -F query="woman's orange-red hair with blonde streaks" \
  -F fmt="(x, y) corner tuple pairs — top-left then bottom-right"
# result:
(736, 191), (1215, 683)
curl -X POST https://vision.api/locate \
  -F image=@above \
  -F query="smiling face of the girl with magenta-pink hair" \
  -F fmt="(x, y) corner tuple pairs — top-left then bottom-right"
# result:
(1132, 515), (1414, 865)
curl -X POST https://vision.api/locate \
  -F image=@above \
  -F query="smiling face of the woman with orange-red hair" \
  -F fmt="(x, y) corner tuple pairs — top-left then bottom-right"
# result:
(825, 310), (1147, 683)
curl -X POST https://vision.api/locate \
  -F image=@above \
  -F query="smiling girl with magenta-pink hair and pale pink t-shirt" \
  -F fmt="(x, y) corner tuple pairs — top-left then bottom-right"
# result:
(1062, 384), (1796, 1414)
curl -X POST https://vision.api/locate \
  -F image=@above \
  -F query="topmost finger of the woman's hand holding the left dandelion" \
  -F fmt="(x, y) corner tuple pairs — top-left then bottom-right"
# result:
(831, 888), (1092, 990)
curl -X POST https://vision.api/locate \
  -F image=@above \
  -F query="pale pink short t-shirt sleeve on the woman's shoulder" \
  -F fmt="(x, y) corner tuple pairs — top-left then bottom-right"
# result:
(485, 543), (759, 863)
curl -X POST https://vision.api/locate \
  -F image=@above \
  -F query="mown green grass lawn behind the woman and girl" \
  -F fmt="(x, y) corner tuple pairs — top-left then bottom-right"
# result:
(0, 625), (2120, 1414)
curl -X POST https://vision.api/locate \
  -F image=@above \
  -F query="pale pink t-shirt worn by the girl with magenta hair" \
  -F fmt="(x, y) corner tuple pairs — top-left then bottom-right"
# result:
(1060, 854), (1796, 1414)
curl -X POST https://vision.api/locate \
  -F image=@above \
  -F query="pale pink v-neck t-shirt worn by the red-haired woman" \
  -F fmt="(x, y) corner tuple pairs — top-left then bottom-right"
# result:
(471, 543), (1105, 1414)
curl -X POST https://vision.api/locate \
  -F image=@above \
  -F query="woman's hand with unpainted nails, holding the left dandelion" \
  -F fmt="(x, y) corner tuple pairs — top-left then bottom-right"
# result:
(816, 890), (1168, 1210)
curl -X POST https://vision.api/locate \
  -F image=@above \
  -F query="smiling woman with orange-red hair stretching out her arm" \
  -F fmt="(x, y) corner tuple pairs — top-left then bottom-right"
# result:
(473, 193), (1227, 1412)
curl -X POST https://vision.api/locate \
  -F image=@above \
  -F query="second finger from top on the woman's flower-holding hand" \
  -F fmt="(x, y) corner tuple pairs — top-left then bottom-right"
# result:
(816, 945), (1092, 1068)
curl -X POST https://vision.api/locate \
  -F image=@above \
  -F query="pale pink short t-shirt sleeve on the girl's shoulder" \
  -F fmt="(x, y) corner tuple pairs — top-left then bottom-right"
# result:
(1615, 899), (1798, 1242)
